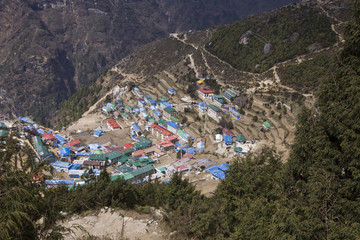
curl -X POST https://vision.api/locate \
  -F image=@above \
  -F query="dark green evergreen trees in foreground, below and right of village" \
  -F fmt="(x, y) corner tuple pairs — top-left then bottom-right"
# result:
(0, 0), (360, 239)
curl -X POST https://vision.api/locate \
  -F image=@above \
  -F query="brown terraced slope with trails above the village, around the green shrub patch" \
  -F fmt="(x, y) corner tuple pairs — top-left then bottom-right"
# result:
(56, 1), (350, 159)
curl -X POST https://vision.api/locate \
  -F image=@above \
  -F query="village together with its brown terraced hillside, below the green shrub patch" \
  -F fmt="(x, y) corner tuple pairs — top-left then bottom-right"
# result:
(0, 0), (341, 194)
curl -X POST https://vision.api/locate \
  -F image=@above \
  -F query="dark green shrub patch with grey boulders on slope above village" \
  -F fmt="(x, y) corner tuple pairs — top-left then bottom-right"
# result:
(206, 5), (336, 72)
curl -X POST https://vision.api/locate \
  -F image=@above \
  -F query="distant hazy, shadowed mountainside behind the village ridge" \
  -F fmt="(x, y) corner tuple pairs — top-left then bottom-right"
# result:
(0, 0), (296, 122)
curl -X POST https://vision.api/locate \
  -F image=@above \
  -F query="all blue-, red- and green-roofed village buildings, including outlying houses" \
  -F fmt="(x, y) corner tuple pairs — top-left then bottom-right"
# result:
(0, 77), (278, 189)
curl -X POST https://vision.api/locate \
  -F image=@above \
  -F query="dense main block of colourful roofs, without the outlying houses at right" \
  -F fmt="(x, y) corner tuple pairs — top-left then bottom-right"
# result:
(7, 85), (211, 185)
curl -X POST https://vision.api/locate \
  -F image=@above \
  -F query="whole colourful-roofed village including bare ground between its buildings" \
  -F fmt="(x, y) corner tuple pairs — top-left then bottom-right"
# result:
(1, 79), (273, 194)
